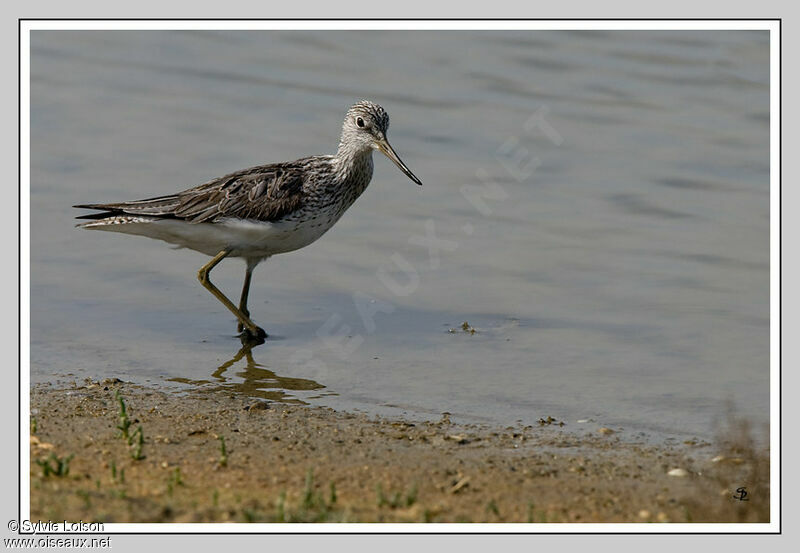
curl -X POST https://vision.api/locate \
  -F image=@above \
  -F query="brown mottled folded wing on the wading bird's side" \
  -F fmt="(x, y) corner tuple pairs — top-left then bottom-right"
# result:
(173, 162), (303, 223)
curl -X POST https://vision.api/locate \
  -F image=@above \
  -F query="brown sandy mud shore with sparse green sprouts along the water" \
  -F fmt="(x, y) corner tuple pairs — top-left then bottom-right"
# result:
(30, 380), (769, 523)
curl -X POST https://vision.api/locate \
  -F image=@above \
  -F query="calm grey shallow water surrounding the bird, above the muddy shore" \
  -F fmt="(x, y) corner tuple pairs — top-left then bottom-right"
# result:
(31, 31), (769, 439)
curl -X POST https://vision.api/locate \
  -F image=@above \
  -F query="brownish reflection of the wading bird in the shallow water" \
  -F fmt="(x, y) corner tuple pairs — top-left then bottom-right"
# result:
(168, 338), (328, 404)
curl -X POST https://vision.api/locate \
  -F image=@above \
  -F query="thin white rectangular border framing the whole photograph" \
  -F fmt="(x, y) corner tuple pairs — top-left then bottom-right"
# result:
(19, 19), (782, 535)
